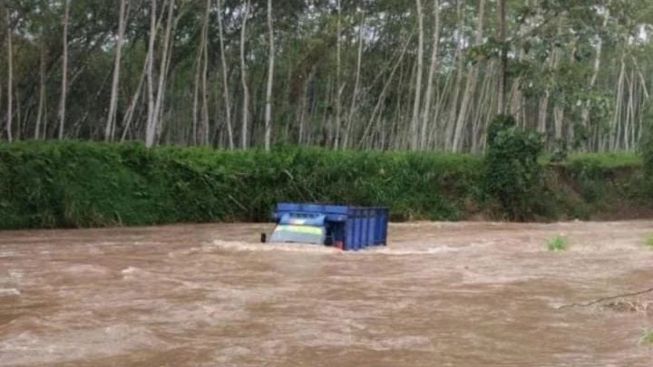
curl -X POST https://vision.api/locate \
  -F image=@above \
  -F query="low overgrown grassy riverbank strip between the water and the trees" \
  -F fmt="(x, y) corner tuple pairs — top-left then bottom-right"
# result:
(0, 142), (651, 229)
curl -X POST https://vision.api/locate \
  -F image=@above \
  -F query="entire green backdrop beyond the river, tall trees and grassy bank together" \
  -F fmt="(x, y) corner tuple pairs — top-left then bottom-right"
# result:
(0, 0), (653, 228)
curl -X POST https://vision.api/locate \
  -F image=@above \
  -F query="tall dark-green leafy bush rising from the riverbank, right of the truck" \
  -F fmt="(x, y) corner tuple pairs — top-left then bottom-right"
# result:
(485, 116), (544, 220)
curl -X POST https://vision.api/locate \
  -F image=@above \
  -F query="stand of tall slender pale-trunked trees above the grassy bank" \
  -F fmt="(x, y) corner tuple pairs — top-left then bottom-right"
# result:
(0, 0), (653, 152)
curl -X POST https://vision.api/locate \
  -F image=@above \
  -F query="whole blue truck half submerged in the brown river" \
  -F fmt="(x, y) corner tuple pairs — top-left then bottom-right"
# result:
(269, 203), (389, 251)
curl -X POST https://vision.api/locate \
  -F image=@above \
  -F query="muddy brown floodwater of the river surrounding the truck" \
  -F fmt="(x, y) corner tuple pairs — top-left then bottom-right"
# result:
(0, 221), (653, 367)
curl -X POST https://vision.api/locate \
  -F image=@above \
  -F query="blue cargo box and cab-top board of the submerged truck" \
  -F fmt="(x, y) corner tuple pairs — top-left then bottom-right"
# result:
(273, 203), (389, 251)
